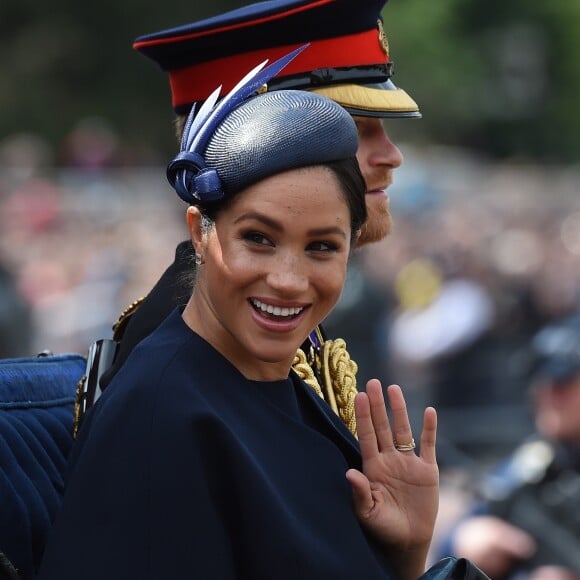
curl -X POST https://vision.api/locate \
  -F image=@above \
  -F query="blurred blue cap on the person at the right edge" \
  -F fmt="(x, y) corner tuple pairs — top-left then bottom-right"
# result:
(532, 314), (580, 383)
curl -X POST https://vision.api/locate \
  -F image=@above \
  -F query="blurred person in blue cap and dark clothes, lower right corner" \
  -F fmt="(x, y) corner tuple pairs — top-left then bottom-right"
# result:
(443, 313), (580, 580)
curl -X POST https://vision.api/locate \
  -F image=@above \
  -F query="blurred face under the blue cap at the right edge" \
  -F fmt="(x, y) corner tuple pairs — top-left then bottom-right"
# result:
(533, 372), (580, 448)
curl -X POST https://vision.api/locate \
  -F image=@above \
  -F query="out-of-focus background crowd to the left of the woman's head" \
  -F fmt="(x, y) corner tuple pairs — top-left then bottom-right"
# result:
(0, 120), (181, 357)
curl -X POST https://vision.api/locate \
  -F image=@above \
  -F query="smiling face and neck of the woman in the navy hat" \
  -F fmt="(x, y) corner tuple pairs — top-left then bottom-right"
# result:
(184, 167), (351, 380)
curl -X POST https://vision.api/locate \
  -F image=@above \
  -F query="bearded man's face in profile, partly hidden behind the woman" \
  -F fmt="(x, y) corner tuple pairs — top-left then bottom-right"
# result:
(353, 116), (403, 247)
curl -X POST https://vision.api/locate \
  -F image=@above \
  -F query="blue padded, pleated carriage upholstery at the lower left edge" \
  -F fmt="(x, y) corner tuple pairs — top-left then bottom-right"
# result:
(0, 354), (86, 579)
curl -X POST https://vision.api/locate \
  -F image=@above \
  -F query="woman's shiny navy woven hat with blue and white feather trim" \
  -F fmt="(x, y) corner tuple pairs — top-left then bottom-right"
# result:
(167, 45), (358, 205)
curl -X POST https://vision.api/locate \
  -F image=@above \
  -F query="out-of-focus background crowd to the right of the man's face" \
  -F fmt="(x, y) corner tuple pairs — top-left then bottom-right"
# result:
(328, 149), (580, 465)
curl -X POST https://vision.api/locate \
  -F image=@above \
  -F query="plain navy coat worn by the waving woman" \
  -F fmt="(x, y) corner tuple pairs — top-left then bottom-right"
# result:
(39, 310), (393, 580)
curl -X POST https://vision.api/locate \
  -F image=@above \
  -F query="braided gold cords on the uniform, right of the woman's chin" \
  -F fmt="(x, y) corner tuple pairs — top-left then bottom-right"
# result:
(292, 328), (358, 437)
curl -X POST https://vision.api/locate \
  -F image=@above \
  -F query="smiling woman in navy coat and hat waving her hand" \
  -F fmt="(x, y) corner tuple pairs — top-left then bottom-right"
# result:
(39, 53), (438, 580)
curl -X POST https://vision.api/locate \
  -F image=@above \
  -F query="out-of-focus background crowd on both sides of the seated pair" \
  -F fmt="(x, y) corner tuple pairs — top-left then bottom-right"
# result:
(0, 120), (580, 572)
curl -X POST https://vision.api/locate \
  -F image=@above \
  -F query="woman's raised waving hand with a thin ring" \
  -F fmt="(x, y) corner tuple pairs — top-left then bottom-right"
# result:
(346, 379), (439, 578)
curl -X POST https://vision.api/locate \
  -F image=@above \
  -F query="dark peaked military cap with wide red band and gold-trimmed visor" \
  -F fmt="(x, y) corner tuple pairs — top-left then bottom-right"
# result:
(133, 0), (421, 117)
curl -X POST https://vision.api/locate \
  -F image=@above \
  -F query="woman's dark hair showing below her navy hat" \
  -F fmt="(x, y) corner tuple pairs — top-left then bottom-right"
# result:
(197, 157), (367, 241)
